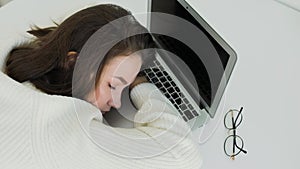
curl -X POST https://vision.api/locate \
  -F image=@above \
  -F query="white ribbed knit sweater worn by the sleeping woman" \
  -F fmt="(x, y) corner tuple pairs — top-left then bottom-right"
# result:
(0, 72), (202, 169)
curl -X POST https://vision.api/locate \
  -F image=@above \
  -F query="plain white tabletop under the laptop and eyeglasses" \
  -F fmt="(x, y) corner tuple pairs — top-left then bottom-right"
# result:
(0, 0), (300, 169)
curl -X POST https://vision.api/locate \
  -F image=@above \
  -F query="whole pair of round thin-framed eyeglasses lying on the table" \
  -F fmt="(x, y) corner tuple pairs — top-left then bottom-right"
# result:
(224, 107), (247, 160)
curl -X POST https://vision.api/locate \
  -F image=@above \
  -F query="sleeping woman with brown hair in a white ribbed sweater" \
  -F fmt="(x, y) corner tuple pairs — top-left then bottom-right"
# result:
(0, 4), (202, 169)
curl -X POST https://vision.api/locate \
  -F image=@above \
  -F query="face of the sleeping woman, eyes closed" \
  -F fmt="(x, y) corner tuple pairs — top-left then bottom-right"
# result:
(86, 54), (142, 114)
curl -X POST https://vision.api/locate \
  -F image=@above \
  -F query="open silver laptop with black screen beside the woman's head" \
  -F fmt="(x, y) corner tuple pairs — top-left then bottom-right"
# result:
(144, 0), (237, 129)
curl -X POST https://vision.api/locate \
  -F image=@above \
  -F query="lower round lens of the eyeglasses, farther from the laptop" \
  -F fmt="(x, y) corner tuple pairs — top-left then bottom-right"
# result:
(224, 135), (244, 157)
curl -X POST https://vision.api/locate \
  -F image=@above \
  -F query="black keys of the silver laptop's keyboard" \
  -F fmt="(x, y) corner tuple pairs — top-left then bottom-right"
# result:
(144, 60), (199, 121)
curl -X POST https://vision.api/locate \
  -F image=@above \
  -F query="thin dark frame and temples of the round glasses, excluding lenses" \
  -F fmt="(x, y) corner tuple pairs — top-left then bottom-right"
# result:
(224, 107), (247, 160)
